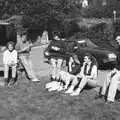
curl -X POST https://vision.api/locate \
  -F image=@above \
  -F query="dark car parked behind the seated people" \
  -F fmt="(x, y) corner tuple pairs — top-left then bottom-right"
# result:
(44, 39), (120, 68)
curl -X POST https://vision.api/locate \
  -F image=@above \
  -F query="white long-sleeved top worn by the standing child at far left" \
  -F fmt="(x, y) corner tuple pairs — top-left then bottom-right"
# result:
(3, 50), (17, 65)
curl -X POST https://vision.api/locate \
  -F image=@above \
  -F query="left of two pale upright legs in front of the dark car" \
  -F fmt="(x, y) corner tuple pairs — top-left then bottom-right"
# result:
(50, 58), (57, 80)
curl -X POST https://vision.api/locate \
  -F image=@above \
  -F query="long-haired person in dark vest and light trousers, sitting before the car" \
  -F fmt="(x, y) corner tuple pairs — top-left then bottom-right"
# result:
(65, 53), (101, 96)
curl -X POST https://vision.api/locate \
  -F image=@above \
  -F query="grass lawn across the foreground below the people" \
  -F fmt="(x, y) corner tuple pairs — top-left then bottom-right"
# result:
(0, 76), (120, 120)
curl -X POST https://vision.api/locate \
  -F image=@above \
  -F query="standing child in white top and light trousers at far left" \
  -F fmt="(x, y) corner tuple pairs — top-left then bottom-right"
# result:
(3, 41), (18, 86)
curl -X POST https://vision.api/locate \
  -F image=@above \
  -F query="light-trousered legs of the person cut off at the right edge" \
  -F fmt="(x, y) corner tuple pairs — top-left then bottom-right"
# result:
(97, 65), (120, 103)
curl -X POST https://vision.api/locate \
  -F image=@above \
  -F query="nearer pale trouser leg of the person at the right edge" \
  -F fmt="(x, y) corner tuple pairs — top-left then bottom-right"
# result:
(107, 73), (120, 102)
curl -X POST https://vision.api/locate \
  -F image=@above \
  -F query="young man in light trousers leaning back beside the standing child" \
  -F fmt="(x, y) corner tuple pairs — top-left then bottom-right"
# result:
(16, 31), (40, 82)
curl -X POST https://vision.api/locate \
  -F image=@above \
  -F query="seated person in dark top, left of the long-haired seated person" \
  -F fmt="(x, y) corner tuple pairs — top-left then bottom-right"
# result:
(46, 53), (81, 91)
